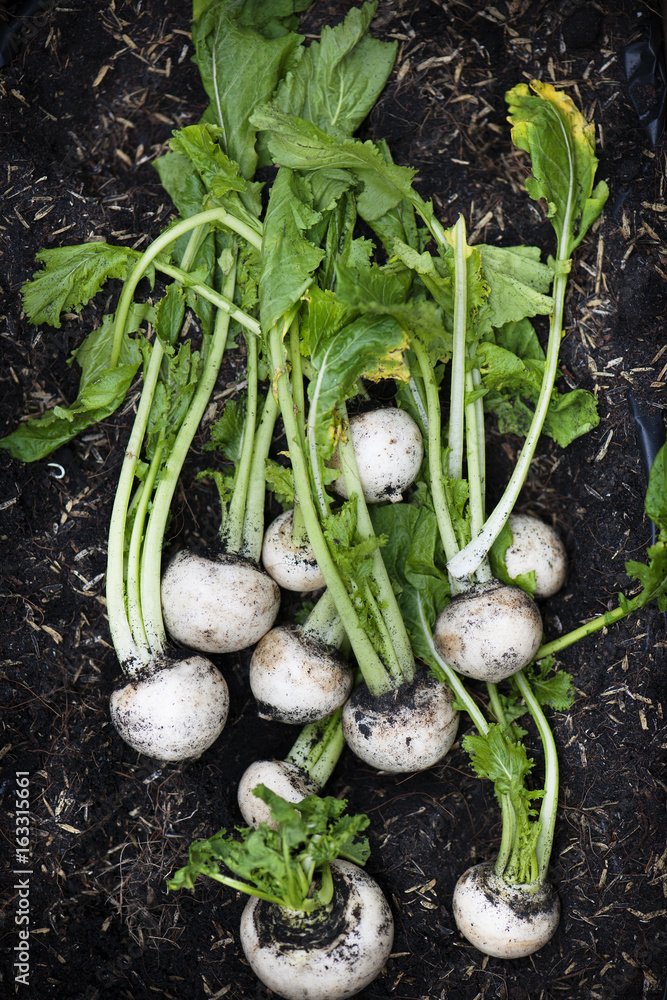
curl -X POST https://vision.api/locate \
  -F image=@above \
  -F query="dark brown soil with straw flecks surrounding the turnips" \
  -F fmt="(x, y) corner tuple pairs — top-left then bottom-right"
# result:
(0, 0), (667, 1000)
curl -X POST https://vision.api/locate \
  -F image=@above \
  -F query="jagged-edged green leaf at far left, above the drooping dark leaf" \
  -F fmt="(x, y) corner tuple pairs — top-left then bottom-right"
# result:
(22, 243), (144, 328)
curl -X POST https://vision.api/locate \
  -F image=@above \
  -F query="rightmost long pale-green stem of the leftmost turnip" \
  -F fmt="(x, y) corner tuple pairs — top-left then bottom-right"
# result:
(141, 261), (236, 653)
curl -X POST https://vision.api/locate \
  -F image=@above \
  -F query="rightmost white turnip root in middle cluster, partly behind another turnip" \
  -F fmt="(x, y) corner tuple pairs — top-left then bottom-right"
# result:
(505, 514), (567, 597)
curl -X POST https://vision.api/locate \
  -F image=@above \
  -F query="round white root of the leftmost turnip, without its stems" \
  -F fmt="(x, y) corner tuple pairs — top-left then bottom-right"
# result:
(110, 656), (229, 761)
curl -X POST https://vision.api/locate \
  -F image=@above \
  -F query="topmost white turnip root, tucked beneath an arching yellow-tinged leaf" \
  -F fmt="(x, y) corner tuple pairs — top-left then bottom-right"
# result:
(329, 407), (424, 503)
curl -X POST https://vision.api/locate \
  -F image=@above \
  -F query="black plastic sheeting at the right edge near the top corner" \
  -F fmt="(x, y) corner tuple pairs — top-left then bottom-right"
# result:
(623, 12), (667, 146)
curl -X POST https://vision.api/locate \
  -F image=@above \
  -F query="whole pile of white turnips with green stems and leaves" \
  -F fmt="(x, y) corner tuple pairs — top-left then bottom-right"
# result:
(2, 0), (667, 1000)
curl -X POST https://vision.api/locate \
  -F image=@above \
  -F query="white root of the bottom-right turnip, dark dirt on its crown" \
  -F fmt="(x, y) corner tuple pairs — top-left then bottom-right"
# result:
(452, 863), (560, 958)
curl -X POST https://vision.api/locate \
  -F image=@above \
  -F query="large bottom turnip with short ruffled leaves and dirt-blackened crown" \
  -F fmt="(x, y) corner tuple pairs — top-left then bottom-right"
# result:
(169, 785), (394, 1000)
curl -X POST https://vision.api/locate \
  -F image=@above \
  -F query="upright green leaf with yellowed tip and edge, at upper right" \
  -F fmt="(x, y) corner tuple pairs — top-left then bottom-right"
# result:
(506, 80), (609, 257)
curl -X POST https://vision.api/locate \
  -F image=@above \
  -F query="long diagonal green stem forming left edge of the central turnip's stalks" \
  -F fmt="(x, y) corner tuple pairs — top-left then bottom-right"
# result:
(270, 325), (394, 695)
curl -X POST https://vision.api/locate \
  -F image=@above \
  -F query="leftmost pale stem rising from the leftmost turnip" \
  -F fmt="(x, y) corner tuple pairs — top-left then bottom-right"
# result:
(106, 337), (164, 676)
